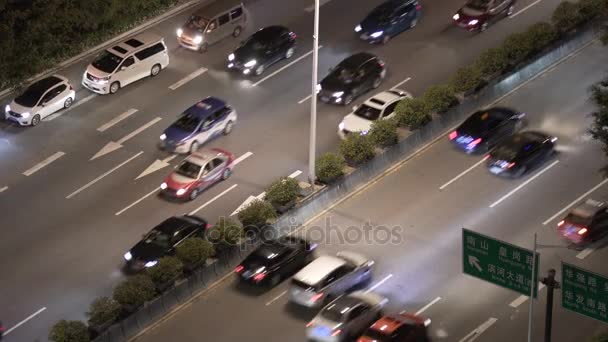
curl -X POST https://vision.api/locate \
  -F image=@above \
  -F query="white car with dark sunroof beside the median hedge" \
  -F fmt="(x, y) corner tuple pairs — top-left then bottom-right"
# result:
(338, 89), (412, 139)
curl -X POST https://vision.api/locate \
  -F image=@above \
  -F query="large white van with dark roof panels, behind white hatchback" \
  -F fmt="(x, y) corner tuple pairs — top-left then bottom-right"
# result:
(82, 32), (169, 94)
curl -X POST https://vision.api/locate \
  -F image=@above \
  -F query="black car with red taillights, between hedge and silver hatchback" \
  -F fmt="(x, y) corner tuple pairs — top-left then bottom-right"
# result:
(234, 236), (316, 287)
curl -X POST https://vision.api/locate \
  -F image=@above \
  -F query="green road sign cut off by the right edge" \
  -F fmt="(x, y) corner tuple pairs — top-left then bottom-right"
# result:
(562, 262), (608, 323)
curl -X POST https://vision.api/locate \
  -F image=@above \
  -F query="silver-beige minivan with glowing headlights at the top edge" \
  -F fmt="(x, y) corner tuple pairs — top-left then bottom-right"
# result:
(177, 0), (247, 52)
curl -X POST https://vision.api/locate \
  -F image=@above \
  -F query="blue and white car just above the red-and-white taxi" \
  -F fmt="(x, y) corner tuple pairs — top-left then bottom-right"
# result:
(160, 96), (237, 153)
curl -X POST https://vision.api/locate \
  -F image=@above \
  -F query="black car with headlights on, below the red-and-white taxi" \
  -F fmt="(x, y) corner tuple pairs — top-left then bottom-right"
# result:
(124, 215), (210, 271)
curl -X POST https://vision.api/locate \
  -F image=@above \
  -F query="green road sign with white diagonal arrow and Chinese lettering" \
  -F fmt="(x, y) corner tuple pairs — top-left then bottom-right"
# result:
(462, 228), (539, 298)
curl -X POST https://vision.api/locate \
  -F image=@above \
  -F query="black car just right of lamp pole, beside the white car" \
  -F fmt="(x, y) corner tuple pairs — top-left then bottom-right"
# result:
(317, 52), (386, 106)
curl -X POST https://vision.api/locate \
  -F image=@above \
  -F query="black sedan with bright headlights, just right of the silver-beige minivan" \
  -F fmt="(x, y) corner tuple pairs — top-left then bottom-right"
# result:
(227, 26), (296, 76)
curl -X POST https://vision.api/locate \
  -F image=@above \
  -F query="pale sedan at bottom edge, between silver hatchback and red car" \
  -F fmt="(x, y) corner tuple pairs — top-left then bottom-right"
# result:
(306, 291), (388, 342)
